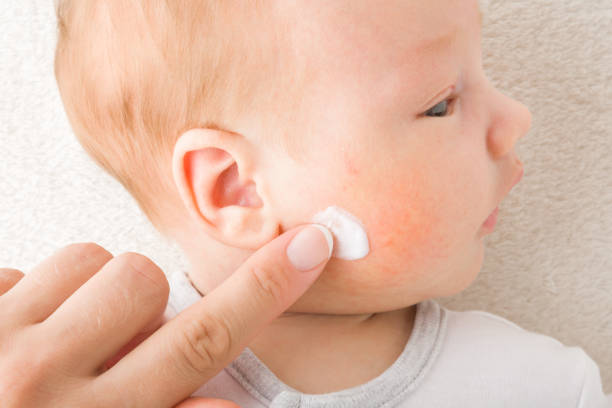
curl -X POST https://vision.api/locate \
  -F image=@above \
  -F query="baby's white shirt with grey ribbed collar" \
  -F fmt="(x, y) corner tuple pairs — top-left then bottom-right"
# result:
(167, 273), (612, 408)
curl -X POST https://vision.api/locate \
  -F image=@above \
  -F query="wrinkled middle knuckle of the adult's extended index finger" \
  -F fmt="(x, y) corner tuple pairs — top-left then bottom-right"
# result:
(178, 314), (233, 375)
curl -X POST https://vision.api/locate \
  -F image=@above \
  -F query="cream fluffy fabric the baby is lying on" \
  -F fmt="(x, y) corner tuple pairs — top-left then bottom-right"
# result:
(0, 0), (612, 393)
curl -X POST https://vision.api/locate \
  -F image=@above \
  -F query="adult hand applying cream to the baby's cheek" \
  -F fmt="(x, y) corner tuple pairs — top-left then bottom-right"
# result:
(0, 226), (333, 408)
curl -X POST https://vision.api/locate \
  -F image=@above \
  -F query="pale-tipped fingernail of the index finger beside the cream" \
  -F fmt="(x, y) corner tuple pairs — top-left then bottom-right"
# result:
(287, 224), (334, 272)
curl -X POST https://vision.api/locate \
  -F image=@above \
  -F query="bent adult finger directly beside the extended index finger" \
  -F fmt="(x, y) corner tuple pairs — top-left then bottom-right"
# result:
(38, 252), (170, 375)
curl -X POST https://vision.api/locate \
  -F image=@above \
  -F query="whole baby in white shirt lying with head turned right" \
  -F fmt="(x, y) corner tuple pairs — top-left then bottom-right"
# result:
(55, 0), (612, 408)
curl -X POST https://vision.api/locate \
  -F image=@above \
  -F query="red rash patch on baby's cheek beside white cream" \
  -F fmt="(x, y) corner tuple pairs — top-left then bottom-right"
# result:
(341, 151), (441, 275)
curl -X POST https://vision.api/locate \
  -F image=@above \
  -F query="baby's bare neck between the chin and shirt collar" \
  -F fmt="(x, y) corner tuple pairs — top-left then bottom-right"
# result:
(248, 305), (416, 394)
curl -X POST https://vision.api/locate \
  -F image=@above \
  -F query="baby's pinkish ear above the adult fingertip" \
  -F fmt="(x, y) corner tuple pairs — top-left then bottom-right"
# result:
(172, 128), (280, 250)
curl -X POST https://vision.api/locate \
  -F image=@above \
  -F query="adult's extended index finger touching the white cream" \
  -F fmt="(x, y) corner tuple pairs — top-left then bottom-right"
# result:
(95, 224), (333, 407)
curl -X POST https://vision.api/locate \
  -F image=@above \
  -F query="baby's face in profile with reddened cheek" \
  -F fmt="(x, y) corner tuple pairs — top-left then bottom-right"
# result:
(258, 0), (531, 313)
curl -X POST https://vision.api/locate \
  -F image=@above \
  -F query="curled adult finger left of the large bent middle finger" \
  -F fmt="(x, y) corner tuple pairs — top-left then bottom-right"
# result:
(0, 242), (113, 326)
